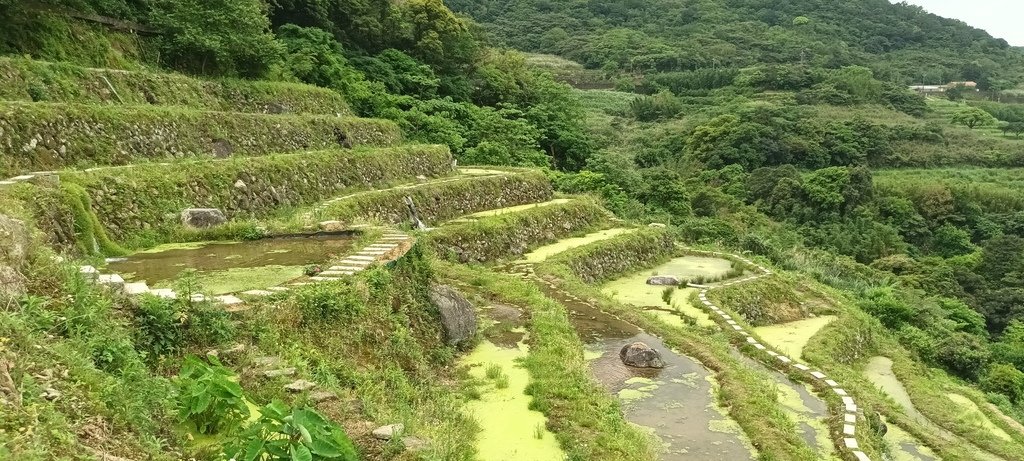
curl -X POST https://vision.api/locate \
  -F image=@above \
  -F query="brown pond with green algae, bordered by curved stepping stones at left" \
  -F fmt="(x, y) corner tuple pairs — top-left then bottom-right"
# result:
(104, 236), (352, 294)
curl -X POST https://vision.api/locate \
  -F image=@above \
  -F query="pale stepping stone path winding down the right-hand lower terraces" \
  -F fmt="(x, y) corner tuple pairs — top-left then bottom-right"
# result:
(689, 251), (870, 461)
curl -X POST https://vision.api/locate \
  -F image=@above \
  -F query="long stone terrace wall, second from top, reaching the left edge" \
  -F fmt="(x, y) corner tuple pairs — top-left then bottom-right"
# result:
(0, 102), (401, 176)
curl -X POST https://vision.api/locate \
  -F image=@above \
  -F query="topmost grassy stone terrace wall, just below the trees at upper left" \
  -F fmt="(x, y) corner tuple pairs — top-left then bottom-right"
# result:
(0, 58), (352, 116)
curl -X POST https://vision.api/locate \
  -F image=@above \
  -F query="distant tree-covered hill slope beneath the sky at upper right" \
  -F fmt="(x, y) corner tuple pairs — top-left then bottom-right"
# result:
(447, 0), (1024, 89)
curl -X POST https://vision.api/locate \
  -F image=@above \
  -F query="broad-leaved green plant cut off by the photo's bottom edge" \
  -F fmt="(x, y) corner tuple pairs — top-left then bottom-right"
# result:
(225, 401), (358, 461)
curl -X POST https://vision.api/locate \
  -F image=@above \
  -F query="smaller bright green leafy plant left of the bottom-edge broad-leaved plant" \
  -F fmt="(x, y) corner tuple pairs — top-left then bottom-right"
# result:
(177, 355), (249, 434)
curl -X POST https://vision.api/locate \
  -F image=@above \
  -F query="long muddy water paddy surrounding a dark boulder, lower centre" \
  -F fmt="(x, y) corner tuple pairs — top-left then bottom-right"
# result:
(542, 287), (755, 461)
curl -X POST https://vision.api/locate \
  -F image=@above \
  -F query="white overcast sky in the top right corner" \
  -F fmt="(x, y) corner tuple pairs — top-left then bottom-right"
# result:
(893, 0), (1024, 46)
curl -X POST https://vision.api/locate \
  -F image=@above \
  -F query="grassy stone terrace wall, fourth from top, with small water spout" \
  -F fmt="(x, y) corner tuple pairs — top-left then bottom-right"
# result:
(316, 171), (553, 224)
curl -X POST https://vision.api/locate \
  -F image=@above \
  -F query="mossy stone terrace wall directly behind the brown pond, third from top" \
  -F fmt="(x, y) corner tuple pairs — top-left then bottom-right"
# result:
(16, 145), (452, 253)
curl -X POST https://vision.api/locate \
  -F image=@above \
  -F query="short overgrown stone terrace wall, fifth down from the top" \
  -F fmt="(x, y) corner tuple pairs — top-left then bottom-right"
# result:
(426, 199), (610, 262)
